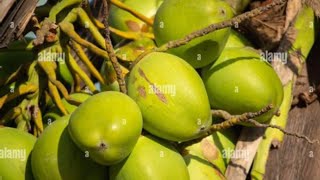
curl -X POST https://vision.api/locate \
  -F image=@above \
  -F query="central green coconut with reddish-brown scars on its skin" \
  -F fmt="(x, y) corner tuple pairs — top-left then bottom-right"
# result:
(128, 52), (212, 141)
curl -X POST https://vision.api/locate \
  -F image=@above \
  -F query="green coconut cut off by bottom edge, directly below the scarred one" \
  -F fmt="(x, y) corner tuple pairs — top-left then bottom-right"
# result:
(109, 136), (189, 180)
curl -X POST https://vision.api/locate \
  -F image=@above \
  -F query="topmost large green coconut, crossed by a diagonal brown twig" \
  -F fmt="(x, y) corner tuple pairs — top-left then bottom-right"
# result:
(153, 0), (233, 68)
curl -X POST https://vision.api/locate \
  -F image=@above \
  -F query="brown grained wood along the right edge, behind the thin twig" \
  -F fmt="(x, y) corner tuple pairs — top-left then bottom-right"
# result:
(265, 33), (320, 180)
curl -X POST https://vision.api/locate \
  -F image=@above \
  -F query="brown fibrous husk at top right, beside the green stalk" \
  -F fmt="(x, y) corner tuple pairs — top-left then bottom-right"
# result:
(240, 0), (302, 51)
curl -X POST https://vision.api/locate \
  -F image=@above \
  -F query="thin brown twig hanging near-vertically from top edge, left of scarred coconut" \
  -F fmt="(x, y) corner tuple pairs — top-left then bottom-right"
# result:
(103, 0), (127, 94)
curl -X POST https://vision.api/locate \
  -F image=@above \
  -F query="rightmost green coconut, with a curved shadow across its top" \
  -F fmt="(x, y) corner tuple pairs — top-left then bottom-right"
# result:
(202, 47), (283, 122)
